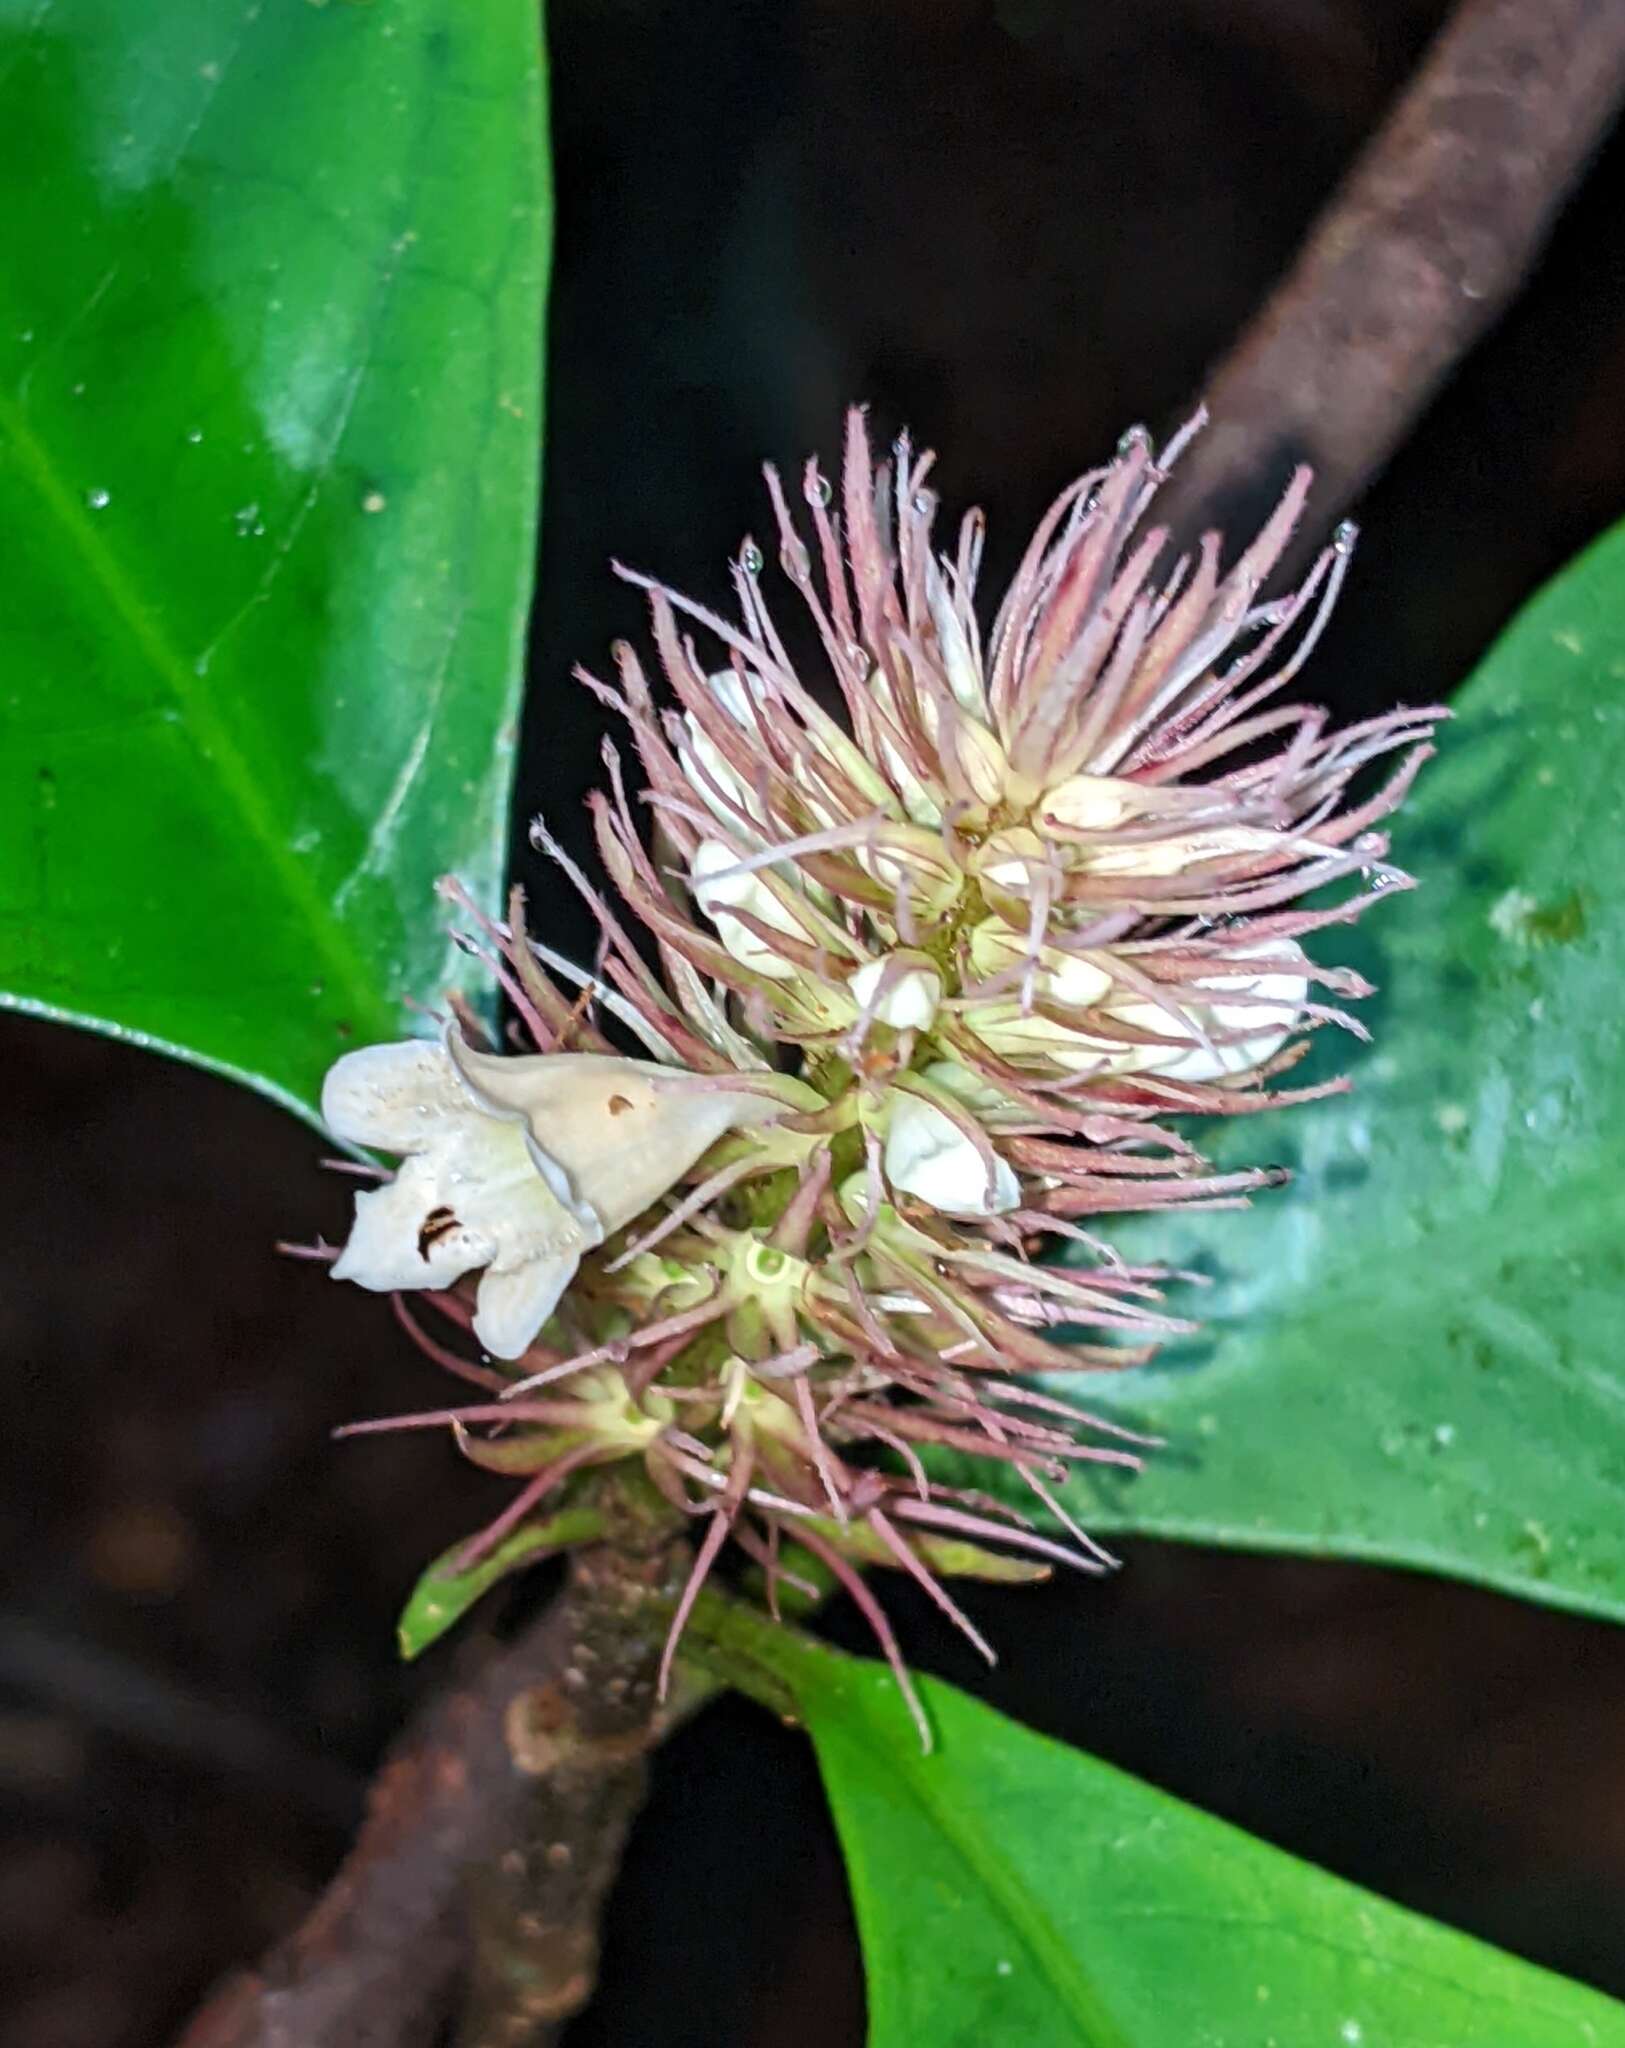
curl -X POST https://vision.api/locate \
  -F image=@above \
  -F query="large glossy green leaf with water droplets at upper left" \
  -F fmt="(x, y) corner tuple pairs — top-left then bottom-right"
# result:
(0, 0), (549, 1114)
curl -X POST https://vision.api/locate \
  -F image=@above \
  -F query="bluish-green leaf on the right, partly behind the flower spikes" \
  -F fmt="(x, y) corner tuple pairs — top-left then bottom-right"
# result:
(961, 528), (1625, 1618)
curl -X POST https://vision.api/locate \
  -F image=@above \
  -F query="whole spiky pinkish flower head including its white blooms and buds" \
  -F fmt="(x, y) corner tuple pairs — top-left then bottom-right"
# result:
(311, 412), (1441, 1744)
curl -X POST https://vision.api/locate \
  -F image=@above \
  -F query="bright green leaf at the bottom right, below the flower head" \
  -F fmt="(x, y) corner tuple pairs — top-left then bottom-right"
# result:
(750, 1622), (1625, 2048)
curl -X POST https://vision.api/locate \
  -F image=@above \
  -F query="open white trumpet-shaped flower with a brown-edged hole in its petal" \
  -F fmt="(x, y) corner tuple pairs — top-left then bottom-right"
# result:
(322, 1030), (777, 1358)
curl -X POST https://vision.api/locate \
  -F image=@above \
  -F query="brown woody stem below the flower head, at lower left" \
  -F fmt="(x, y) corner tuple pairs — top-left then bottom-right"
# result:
(180, 1534), (680, 2048)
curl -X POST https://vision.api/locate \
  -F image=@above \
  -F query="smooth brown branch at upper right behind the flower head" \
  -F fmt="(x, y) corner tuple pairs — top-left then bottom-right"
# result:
(1156, 0), (1625, 561)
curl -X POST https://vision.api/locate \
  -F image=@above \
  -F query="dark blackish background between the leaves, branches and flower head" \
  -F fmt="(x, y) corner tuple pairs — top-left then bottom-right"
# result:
(0, 0), (1625, 2048)
